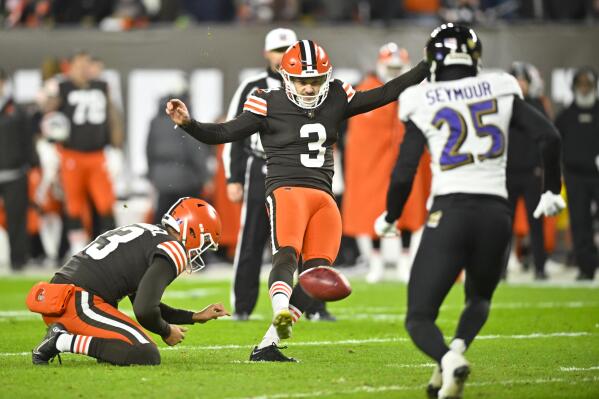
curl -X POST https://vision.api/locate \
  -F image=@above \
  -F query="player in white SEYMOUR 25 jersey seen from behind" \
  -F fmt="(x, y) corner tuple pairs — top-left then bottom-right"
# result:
(375, 24), (565, 398)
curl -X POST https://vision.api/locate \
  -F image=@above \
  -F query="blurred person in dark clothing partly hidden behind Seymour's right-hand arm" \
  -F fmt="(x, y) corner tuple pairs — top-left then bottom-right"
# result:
(507, 61), (550, 280)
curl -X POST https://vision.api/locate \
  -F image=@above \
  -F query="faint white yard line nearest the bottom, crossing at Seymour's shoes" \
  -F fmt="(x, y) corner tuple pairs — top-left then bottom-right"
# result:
(229, 377), (599, 399)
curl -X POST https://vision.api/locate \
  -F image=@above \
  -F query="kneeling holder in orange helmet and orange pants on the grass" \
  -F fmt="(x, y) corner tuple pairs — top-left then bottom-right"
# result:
(28, 197), (229, 365)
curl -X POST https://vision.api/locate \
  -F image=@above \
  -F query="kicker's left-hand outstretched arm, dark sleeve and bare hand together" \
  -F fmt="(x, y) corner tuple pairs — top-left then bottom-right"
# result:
(166, 99), (264, 144)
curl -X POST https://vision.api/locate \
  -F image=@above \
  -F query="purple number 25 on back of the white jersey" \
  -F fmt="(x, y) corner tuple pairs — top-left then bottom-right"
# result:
(431, 99), (505, 170)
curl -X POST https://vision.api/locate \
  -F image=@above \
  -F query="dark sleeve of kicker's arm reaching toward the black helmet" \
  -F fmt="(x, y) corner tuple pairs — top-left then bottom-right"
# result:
(346, 61), (429, 118)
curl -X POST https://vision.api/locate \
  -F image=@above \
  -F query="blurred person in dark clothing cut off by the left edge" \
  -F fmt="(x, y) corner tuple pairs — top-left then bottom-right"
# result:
(0, 69), (33, 271)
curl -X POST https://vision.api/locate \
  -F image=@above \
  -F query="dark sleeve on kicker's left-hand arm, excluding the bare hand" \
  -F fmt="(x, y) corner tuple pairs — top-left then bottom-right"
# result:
(181, 112), (264, 144)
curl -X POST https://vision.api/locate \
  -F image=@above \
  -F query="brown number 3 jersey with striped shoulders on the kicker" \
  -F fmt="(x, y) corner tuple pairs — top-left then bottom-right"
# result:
(244, 80), (355, 196)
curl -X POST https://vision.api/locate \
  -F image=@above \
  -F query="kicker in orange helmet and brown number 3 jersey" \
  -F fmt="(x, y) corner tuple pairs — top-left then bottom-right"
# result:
(166, 40), (428, 361)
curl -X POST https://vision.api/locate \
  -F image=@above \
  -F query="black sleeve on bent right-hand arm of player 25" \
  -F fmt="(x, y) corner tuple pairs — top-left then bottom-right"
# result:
(511, 96), (562, 194)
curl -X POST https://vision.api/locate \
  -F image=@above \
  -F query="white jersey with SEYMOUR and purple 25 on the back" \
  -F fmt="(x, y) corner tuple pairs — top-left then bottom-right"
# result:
(399, 73), (522, 198)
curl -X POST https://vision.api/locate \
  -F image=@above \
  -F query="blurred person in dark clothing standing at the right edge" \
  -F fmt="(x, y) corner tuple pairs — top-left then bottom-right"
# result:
(555, 68), (599, 280)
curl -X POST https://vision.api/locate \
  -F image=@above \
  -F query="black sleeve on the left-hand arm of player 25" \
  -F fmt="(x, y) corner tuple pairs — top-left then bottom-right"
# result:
(385, 121), (426, 223)
